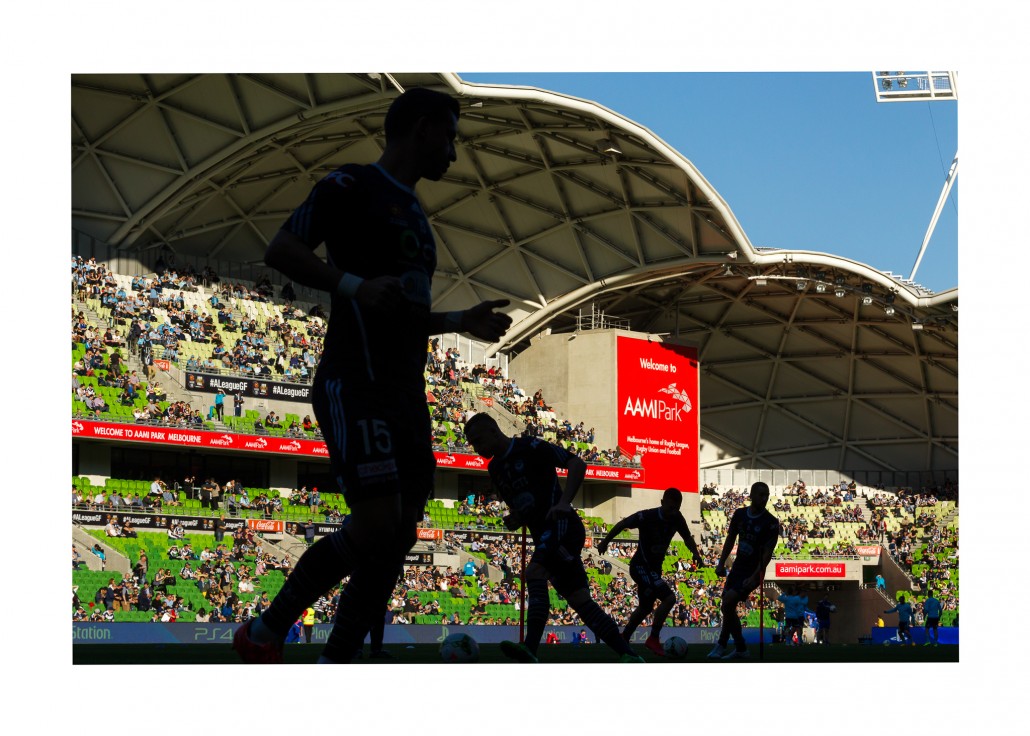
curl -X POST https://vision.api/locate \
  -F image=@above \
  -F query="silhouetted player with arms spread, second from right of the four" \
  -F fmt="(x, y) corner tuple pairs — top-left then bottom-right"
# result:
(597, 488), (701, 657)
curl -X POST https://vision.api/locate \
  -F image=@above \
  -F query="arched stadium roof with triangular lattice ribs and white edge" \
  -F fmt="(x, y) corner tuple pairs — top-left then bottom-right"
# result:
(71, 72), (958, 470)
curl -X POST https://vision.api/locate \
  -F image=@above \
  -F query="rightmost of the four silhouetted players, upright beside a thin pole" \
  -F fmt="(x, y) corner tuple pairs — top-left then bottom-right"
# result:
(708, 481), (780, 661)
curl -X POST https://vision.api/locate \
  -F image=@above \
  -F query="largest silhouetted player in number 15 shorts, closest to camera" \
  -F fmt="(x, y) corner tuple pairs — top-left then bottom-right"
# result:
(233, 87), (511, 663)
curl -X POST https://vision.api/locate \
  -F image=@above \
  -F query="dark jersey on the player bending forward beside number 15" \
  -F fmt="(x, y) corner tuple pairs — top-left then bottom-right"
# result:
(488, 437), (575, 540)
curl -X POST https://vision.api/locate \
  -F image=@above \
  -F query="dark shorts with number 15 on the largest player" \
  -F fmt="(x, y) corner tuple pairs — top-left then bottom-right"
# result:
(311, 377), (437, 505)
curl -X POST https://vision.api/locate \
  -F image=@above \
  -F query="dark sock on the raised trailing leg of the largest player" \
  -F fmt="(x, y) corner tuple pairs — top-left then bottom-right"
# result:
(251, 529), (355, 643)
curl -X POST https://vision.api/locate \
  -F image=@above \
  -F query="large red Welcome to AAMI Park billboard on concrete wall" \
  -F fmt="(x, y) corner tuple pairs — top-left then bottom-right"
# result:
(617, 336), (700, 493)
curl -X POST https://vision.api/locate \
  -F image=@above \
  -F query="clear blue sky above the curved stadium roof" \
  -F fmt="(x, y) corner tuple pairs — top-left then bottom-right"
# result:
(458, 71), (962, 291)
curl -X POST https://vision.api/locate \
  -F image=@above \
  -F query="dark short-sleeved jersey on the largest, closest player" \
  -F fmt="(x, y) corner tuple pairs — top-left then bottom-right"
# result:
(283, 164), (437, 393)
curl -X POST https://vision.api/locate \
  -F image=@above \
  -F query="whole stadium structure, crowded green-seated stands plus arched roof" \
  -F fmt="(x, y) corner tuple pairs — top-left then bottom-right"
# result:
(71, 73), (958, 654)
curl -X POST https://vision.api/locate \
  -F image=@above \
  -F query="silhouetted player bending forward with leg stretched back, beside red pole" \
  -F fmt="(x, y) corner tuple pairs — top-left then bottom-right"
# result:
(465, 414), (644, 662)
